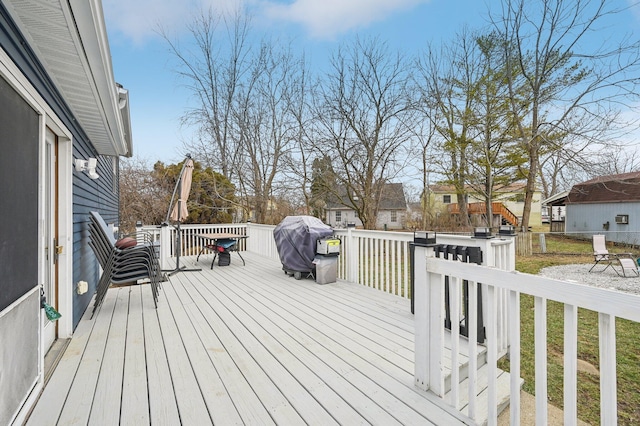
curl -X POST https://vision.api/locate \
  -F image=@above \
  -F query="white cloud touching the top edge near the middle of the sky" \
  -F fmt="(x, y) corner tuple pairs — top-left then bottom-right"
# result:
(263, 0), (430, 38)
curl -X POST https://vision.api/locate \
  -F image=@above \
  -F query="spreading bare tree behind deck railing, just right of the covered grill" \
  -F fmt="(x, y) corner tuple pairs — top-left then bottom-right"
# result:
(316, 39), (414, 229)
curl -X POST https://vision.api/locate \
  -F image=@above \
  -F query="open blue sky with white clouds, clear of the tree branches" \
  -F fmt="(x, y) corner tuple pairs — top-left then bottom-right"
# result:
(102, 0), (640, 163)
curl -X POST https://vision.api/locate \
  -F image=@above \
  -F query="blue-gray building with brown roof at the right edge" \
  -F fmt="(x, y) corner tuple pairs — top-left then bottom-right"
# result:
(565, 172), (640, 245)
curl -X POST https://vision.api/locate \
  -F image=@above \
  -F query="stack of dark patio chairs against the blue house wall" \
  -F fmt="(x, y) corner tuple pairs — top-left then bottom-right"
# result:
(89, 212), (164, 316)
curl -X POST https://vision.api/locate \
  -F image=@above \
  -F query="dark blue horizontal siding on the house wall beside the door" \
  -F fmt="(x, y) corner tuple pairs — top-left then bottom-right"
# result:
(0, 3), (119, 328)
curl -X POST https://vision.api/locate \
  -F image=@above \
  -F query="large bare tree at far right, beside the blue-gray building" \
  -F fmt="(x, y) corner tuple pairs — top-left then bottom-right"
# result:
(493, 0), (640, 229)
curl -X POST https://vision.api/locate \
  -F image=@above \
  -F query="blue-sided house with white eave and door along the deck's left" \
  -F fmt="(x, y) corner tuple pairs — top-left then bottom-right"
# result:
(0, 0), (131, 425)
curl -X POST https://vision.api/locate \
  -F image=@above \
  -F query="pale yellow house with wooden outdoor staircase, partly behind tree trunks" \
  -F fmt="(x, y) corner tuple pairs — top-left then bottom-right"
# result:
(429, 183), (542, 230)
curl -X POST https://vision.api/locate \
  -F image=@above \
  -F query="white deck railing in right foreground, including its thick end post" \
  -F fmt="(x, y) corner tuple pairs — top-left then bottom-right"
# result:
(415, 247), (640, 425)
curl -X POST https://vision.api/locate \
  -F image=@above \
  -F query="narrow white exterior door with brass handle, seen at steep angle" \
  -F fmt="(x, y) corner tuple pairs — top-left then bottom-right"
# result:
(42, 128), (58, 353)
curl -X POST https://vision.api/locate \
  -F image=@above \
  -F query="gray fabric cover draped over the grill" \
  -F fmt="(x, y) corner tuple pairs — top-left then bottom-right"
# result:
(273, 216), (333, 272)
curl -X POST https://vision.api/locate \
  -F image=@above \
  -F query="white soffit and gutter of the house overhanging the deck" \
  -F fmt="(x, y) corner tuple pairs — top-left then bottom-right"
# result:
(3, 0), (132, 156)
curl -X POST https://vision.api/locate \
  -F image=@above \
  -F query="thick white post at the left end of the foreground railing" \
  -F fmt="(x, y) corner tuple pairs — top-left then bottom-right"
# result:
(414, 245), (445, 398)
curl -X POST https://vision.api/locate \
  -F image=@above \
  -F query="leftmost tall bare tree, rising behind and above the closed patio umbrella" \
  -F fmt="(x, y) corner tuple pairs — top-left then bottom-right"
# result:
(160, 9), (254, 179)
